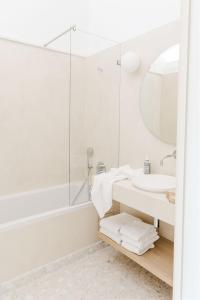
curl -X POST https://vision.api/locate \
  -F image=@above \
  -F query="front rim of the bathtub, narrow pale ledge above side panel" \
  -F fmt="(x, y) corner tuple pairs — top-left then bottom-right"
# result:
(0, 200), (93, 233)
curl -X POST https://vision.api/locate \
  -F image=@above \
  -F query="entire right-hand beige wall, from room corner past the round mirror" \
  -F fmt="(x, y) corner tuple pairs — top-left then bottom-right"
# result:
(81, 22), (179, 239)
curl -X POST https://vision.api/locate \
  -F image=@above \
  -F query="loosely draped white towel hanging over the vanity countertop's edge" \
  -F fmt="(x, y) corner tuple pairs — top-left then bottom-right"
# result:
(91, 166), (143, 218)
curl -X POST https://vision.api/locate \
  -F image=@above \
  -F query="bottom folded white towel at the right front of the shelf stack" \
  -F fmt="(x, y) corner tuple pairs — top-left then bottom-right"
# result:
(121, 233), (159, 250)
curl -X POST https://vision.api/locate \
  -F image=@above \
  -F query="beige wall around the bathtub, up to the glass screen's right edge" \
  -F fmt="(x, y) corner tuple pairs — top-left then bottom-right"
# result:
(0, 35), (120, 195)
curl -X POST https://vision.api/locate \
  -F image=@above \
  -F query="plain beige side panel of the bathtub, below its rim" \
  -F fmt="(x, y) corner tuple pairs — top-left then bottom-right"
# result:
(0, 205), (98, 282)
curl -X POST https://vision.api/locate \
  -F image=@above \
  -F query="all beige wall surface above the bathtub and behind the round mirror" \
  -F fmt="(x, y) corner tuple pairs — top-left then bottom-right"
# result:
(0, 22), (179, 241)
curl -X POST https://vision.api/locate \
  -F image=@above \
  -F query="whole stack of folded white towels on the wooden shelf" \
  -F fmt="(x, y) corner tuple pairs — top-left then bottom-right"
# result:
(100, 213), (159, 255)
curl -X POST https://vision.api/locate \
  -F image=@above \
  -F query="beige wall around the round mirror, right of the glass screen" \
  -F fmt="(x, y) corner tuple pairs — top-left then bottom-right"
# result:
(120, 22), (180, 239)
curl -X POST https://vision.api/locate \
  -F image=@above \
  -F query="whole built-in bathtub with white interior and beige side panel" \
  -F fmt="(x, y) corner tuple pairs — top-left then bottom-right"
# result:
(0, 183), (98, 283)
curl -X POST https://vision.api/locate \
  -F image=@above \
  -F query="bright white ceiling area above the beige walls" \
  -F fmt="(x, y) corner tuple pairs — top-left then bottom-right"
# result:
(0, 0), (181, 56)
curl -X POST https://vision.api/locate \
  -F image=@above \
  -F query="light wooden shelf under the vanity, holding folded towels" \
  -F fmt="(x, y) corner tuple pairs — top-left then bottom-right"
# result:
(98, 232), (174, 287)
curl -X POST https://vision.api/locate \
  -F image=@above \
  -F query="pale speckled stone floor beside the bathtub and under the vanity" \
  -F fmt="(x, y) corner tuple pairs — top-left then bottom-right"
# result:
(1, 247), (172, 300)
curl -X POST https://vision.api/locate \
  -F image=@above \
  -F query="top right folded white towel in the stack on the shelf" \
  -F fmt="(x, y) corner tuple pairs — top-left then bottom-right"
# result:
(120, 221), (156, 242)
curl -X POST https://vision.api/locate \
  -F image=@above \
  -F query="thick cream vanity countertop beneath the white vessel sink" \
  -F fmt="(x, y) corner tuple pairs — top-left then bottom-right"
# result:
(113, 180), (175, 225)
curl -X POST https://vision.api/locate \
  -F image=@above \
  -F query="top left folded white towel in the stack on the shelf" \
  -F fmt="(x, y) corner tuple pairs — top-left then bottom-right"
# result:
(99, 213), (142, 234)
